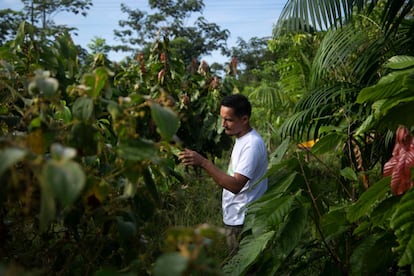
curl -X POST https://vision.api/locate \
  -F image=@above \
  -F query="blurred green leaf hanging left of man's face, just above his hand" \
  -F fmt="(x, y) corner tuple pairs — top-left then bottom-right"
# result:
(151, 103), (180, 141)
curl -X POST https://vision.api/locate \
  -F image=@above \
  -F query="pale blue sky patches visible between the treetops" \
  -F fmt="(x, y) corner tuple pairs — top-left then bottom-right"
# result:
(0, 0), (287, 63)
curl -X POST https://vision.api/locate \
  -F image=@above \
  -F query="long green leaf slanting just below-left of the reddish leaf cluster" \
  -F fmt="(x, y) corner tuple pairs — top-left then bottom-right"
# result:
(347, 177), (390, 222)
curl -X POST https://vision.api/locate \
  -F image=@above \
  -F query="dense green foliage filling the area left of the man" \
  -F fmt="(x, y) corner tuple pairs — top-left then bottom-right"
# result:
(0, 16), (231, 274)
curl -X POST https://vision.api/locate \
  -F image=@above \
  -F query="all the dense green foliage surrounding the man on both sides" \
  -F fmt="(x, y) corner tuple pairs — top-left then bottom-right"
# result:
(0, 0), (414, 275)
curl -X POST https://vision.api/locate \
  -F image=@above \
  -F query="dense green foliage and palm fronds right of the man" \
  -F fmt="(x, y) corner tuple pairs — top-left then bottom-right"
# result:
(224, 0), (414, 275)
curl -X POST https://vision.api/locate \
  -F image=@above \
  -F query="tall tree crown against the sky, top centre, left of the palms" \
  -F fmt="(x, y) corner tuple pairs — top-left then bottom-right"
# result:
(114, 0), (229, 64)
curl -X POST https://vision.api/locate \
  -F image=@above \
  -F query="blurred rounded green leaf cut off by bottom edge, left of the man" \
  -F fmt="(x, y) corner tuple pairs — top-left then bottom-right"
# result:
(154, 252), (188, 276)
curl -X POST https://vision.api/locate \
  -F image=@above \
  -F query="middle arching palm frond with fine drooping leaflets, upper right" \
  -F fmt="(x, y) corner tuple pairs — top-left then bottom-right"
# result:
(311, 20), (389, 86)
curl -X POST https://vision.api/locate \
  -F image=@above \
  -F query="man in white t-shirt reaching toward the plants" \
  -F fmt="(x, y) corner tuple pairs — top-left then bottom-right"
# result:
(179, 94), (267, 254)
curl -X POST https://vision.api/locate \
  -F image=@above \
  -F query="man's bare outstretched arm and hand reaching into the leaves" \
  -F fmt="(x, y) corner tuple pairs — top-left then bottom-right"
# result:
(179, 149), (249, 194)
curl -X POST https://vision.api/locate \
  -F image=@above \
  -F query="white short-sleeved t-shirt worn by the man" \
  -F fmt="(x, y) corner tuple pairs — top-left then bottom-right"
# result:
(222, 129), (267, 225)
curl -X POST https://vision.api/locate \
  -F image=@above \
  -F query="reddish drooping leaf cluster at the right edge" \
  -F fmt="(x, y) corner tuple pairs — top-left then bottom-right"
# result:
(383, 126), (414, 195)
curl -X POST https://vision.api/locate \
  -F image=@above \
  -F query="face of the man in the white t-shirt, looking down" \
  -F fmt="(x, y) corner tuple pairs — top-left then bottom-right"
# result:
(220, 106), (248, 137)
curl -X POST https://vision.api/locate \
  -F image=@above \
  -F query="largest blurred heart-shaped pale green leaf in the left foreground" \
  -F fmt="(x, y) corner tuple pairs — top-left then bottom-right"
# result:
(42, 160), (86, 206)
